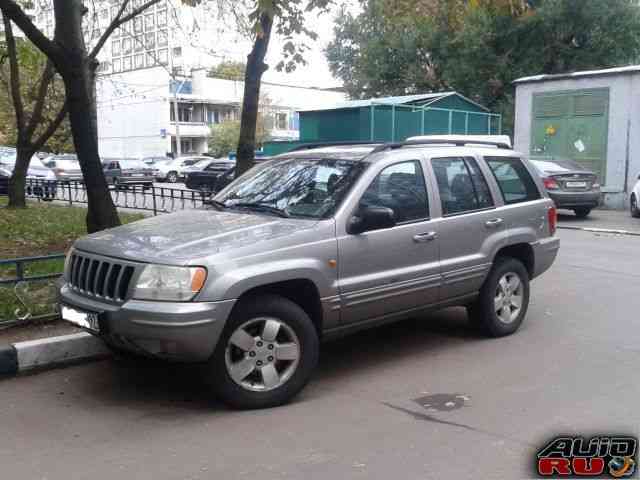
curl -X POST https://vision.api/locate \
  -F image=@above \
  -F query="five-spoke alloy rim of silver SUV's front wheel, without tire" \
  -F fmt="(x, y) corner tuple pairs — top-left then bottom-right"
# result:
(225, 317), (300, 392)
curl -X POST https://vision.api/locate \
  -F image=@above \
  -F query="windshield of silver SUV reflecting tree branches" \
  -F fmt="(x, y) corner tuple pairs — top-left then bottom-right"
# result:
(215, 158), (367, 218)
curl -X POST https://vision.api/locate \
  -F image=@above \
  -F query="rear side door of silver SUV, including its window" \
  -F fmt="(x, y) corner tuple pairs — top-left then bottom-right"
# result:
(429, 153), (507, 300)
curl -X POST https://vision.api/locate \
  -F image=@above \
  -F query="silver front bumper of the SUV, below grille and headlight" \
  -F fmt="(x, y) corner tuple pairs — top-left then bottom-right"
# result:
(59, 284), (235, 362)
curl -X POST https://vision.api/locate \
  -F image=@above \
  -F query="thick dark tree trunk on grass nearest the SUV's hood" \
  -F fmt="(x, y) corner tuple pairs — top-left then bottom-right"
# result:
(54, 0), (120, 233)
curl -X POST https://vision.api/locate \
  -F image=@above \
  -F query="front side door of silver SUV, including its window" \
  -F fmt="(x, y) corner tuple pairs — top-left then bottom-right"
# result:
(338, 160), (440, 324)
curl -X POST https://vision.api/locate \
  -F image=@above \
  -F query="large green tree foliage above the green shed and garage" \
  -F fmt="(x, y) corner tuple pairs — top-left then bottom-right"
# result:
(326, 0), (640, 132)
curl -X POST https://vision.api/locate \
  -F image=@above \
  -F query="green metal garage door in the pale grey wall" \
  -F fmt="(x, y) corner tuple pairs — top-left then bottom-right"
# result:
(531, 88), (609, 183)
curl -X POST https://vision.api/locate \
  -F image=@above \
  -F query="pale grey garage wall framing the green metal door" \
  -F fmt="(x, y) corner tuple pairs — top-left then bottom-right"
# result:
(514, 73), (640, 208)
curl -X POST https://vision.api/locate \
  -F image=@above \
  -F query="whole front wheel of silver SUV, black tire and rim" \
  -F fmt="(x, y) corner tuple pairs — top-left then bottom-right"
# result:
(206, 295), (319, 409)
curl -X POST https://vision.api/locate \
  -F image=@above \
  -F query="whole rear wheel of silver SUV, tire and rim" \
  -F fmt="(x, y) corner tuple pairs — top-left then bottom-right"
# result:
(467, 257), (530, 337)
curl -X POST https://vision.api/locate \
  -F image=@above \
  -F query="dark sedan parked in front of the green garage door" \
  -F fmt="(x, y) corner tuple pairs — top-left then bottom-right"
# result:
(531, 157), (600, 218)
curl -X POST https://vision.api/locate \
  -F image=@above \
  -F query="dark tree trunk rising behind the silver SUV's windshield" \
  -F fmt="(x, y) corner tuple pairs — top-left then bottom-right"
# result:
(236, 13), (273, 177)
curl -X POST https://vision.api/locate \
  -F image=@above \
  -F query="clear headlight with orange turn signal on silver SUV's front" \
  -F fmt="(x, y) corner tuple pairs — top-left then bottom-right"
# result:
(133, 265), (207, 302)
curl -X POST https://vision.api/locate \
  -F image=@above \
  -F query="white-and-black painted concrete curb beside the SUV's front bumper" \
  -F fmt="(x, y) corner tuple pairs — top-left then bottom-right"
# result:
(0, 332), (109, 376)
